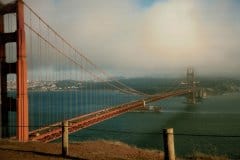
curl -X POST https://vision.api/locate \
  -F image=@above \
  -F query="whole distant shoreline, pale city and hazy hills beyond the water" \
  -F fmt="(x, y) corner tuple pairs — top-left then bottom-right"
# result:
(8, 77), (240, 95)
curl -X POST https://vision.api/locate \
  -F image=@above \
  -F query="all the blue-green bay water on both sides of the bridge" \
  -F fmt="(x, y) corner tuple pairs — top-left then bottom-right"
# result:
(7, 91), (240, 159)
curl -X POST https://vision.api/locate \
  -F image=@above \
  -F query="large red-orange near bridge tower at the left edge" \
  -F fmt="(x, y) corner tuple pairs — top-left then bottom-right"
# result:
(0, 0), (29, 142)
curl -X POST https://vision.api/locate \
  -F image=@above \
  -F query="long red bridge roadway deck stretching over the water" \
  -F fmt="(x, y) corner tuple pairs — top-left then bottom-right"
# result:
(29, 89), (192, 143)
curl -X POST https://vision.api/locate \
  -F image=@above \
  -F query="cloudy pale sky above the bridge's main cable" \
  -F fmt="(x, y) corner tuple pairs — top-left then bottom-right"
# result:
(1, 0), (240, 77)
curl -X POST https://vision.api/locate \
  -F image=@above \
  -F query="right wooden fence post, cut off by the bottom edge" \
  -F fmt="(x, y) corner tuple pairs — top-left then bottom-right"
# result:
(163, 128), (175, 160)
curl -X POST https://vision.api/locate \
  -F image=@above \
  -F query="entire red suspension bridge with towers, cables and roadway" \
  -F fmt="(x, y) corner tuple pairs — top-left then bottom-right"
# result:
(0, 0), (197, 142)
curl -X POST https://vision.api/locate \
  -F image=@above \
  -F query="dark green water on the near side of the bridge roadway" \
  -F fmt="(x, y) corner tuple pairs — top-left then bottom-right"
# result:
(70, 94), (240, 159)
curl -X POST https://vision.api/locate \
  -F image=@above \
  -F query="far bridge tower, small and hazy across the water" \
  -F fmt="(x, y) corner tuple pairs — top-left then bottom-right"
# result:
(187, 67), (196, 104)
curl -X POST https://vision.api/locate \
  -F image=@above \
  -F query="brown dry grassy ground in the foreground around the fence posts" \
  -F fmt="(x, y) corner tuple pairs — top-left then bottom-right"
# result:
(0, 140), (231, 160)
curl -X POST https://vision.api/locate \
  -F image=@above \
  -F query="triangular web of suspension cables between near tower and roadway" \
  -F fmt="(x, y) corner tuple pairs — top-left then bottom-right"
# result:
(22, 1), (143, 133)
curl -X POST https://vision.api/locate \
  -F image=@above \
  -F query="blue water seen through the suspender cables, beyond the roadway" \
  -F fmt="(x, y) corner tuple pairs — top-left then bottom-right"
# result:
(29, 90), (136, 129)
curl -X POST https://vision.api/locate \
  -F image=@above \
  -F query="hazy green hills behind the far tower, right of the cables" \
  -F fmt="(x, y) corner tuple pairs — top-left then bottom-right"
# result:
(120, 77), (240, 94)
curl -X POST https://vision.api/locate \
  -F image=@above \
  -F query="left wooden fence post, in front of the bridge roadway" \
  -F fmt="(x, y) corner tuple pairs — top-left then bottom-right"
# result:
(62, 121), (68, 157)
